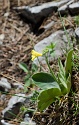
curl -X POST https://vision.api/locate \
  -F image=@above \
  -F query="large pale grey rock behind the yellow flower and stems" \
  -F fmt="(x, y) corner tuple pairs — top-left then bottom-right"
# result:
(34, 29), (73, 65)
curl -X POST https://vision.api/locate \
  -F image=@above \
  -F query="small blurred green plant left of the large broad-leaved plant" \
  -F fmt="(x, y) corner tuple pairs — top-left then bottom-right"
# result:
(19, 63), (38, 92)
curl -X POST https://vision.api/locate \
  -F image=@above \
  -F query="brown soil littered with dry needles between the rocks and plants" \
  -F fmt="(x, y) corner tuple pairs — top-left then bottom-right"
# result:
(0, 0), (79, 125)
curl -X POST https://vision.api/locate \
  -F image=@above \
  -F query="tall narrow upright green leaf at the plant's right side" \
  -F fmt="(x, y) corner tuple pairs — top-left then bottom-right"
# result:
(65, 49), (73, 77)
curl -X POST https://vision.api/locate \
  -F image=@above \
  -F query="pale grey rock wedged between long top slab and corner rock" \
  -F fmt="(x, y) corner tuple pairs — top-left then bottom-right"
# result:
(58, 0), (74, 15)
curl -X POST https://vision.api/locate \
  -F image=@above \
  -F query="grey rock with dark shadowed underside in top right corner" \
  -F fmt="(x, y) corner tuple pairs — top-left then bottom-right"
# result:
(69, 2), (79, 15)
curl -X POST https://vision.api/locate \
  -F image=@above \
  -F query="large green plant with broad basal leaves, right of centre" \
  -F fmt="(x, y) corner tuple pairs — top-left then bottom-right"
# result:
(32, 49), (73, 111)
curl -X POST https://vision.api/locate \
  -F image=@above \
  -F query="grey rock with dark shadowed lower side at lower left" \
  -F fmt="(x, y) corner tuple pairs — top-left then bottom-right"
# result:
(2, 93), (26, 119)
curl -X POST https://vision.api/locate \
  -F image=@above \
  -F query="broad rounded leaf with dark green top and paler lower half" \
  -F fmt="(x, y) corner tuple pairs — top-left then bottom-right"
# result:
(32, 72), (60, 89)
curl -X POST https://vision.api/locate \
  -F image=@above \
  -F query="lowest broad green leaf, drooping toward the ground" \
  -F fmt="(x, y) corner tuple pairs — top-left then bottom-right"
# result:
(38, 88), (62, 111)
